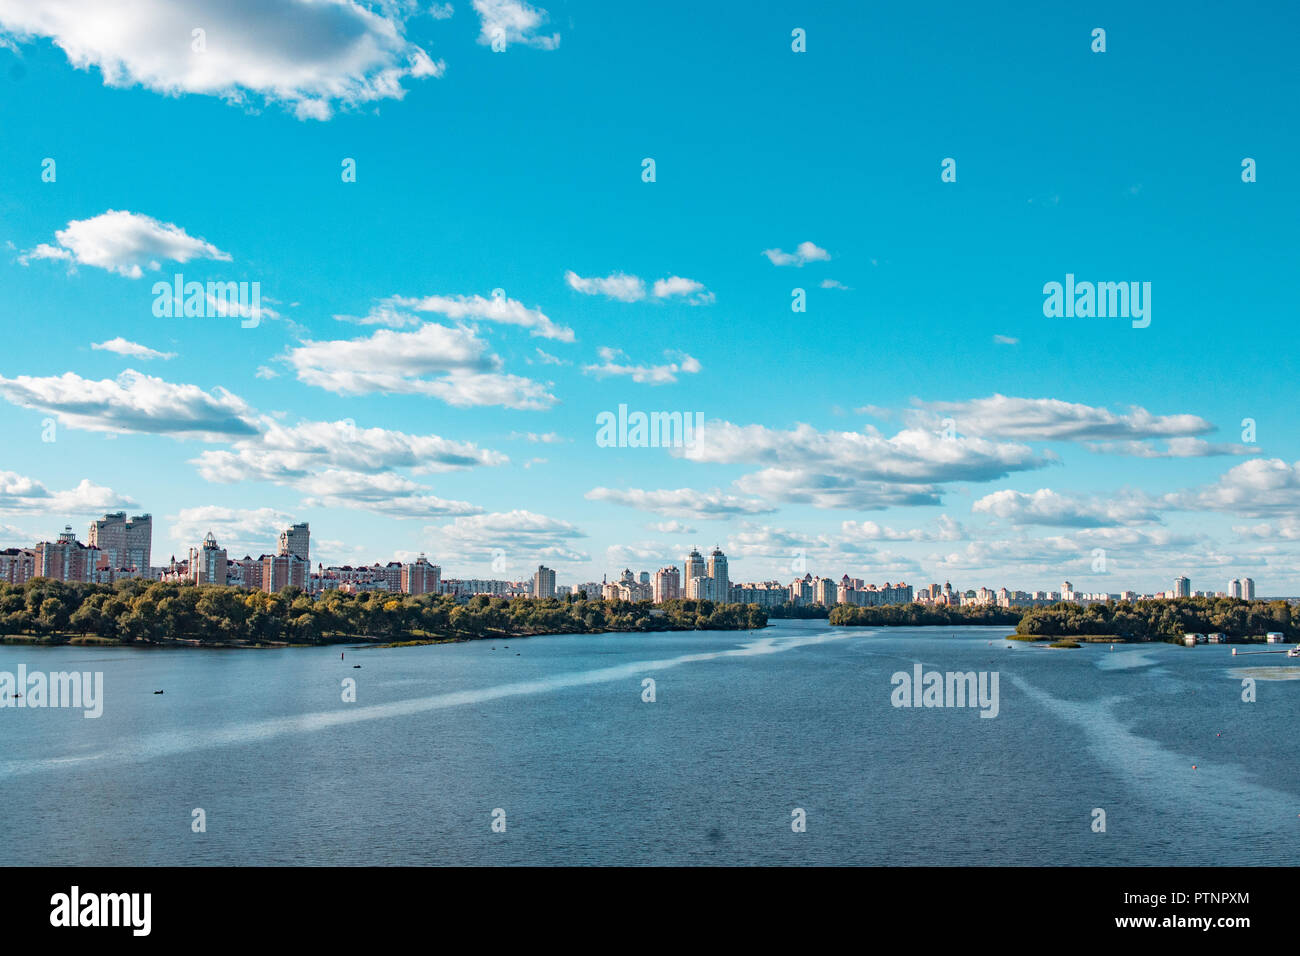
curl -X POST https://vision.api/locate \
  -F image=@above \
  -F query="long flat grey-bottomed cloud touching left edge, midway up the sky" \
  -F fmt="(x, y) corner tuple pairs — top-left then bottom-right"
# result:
(0, 369), (259, 441)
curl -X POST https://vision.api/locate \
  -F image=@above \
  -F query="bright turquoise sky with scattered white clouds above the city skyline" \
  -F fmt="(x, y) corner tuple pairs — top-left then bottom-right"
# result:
(0, 0), (1300, 596)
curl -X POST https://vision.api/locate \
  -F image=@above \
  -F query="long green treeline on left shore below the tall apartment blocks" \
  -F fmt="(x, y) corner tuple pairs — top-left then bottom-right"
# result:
(0, 578), (767, 646)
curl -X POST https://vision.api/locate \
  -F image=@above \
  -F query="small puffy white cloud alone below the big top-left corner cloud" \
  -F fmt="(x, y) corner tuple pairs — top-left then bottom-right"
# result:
(21, 210), (230, 278)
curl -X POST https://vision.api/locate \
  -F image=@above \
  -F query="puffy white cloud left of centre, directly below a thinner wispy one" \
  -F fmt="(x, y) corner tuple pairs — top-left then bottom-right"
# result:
(285, 323), (556, 408)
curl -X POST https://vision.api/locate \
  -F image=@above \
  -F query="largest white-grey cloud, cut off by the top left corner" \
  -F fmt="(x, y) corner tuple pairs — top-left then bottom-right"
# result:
(0, 0), (441, 120)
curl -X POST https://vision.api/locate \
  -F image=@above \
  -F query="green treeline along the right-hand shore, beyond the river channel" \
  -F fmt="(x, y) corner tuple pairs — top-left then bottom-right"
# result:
(826, 597), (1300, 641)
